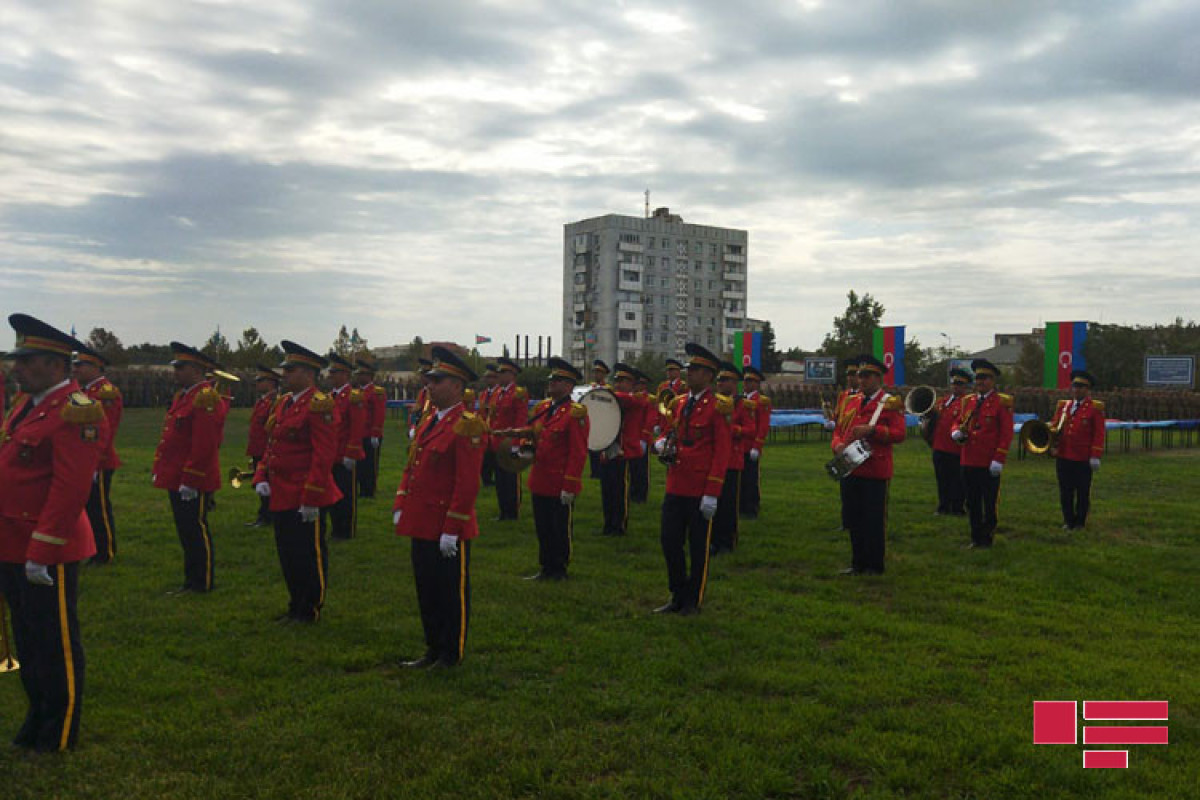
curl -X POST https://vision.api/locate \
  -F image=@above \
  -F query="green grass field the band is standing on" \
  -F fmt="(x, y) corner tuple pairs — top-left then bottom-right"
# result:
(0, 410), (1200, 800)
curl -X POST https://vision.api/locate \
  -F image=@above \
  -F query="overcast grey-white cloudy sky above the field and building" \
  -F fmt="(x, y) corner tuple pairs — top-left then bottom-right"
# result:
(0, 0), (1200, 351)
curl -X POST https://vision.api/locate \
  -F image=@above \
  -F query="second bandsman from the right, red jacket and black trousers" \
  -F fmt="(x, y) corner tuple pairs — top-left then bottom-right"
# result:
(950, 359), (1013, 548)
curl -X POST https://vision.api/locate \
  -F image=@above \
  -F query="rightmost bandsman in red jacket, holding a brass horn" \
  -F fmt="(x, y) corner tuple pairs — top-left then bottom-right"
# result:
(1050, 369), (1105, 530)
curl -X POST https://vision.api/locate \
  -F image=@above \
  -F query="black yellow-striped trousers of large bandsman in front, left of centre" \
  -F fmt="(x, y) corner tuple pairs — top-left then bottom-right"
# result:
(413, 537), (470, 664)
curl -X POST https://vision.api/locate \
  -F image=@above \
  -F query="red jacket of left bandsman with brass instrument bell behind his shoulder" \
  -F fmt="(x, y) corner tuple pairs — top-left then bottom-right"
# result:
(151, 380), (224, 492)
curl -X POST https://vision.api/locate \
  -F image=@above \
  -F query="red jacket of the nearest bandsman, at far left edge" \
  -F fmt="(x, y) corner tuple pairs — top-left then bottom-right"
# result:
(0, 380), (108, 564)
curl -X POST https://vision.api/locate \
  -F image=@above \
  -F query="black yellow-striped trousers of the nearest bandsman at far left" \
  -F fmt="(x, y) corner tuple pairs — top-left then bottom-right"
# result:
(0, 563), (84, 752)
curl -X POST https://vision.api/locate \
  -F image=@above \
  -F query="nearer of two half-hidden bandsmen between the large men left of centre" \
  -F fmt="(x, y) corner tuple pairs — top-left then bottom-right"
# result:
(322, 353), (367, 539)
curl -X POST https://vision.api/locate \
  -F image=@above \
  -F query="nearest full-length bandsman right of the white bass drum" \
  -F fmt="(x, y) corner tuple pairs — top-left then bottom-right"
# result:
(654, 343), (733, 615)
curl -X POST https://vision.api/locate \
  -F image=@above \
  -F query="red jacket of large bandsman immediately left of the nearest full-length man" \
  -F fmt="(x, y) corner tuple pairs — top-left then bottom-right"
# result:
(254, 389), (342, 511)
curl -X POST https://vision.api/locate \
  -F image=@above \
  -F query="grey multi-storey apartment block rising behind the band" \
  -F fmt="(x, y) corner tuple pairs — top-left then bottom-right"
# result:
(563, 209), (749, 366)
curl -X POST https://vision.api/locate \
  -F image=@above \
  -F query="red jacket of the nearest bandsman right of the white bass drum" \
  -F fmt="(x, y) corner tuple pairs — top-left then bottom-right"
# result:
(662, 389), (733, 498)
